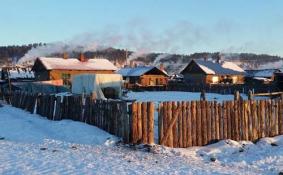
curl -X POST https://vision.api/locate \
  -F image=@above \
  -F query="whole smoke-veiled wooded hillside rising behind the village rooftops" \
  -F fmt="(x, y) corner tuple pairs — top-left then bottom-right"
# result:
(0, 43), (283, 73)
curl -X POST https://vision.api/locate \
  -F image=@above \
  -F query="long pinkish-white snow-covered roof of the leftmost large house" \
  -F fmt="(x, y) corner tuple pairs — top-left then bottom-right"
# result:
(38, 57), (117, 71)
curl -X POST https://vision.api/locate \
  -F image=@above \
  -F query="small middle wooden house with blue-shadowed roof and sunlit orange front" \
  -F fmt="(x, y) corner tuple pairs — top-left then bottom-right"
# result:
(118, 66), (169, 88)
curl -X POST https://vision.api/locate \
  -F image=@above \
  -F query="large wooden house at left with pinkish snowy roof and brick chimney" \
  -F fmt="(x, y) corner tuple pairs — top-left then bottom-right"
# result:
(32, 55), (117, 85)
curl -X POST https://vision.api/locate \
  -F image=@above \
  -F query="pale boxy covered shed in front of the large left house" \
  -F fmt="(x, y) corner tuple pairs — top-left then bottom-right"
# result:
(72, 74), (122, 99)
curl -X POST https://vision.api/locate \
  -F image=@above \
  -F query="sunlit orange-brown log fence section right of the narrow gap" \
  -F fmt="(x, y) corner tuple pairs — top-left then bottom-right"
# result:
(158, 100), (283, 148)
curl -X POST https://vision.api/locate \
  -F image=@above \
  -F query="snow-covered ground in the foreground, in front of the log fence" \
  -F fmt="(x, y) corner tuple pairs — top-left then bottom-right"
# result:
(0, 105), (283, 174)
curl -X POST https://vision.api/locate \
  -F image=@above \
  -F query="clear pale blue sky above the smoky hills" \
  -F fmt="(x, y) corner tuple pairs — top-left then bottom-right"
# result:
(0, 0), (283, 56)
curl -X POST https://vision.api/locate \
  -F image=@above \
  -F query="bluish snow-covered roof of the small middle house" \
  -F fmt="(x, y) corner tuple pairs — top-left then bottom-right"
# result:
(117, 66), (168, 77)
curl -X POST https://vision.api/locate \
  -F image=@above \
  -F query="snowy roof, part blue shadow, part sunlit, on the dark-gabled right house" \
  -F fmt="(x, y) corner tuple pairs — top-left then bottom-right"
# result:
(193, 60), (245, 75)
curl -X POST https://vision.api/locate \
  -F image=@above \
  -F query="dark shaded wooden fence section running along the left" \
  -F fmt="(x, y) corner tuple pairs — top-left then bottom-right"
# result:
(11, 92), (131, 143)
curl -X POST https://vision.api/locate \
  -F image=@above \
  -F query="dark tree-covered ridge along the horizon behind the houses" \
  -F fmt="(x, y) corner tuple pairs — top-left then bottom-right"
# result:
(0, 43), (283, 68)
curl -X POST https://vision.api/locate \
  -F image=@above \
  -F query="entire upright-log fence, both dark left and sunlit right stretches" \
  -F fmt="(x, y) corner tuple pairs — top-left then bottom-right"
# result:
(2, 92), (283, 148)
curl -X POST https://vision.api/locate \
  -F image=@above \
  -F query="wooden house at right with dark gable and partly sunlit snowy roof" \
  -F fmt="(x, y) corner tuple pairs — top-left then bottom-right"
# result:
(181, 60), (245, 85)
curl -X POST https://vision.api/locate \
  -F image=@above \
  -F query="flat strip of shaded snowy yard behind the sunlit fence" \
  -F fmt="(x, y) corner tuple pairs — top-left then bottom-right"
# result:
(127, 91), (265, 102)
